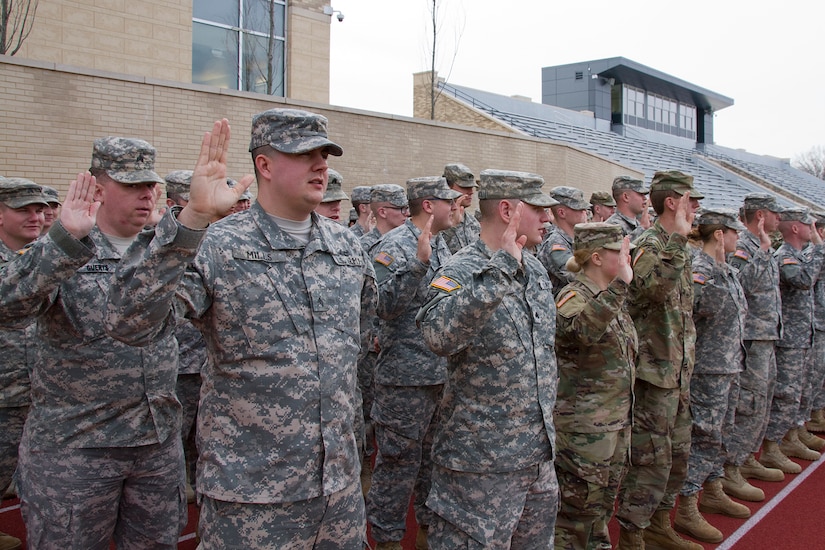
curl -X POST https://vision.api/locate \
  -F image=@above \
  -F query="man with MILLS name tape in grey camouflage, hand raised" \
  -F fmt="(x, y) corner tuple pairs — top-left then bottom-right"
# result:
(106, 109), (376, 550)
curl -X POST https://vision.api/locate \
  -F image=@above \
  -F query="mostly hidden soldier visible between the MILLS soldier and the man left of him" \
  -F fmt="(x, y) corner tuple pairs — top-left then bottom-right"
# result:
(163, 170), (206, 502)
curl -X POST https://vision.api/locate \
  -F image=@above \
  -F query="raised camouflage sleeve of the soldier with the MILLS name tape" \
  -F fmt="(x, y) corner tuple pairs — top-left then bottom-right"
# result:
(105, 208), (208, 346)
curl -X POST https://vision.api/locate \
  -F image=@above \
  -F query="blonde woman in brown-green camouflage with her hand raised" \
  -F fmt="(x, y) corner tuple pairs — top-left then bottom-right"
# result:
(554, 222), (639, 550)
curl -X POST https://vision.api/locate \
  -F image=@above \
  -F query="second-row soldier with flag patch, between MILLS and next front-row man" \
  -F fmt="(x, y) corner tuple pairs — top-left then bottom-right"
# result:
(367, 176), (461, 549)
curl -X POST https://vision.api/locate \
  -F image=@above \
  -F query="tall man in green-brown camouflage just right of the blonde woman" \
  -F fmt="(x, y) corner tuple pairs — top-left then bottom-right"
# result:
(616, 170), (704, 550)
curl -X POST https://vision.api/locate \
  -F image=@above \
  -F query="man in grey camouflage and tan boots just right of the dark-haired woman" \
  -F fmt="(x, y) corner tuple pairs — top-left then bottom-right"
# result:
(722, 193), (788, 484)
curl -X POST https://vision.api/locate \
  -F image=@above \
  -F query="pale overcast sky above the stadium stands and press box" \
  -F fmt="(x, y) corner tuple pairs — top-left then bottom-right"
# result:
(330, 0), (825, 159)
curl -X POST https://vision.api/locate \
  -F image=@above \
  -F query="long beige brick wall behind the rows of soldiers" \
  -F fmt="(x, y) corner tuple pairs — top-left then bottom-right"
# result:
(0, 56), (640, 205)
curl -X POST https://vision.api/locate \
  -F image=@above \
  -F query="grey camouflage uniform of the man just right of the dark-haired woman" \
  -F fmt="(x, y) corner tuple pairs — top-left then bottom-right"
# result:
(727, 229), (782, 466)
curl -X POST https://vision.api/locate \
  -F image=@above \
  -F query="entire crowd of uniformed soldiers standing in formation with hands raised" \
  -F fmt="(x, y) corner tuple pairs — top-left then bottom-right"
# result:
(0, 109), (825, 550)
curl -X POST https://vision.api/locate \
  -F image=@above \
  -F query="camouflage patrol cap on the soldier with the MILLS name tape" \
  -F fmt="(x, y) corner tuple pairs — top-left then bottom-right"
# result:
(249, 109), (344, 157)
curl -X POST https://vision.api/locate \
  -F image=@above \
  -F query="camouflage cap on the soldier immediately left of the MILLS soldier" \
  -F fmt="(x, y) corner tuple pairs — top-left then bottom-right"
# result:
(92, 136), (163, 184)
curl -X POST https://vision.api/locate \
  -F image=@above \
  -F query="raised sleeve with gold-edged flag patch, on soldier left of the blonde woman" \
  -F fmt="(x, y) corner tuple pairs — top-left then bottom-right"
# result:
(416, 250), (519, 356)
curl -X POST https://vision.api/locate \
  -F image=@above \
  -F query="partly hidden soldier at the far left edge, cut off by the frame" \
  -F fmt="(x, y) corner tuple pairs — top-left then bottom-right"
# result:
(0, 178), (49, 550)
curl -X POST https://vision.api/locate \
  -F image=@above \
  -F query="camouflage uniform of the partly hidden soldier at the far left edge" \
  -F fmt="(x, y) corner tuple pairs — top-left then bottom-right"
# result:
(0, 241), (36, 491)
